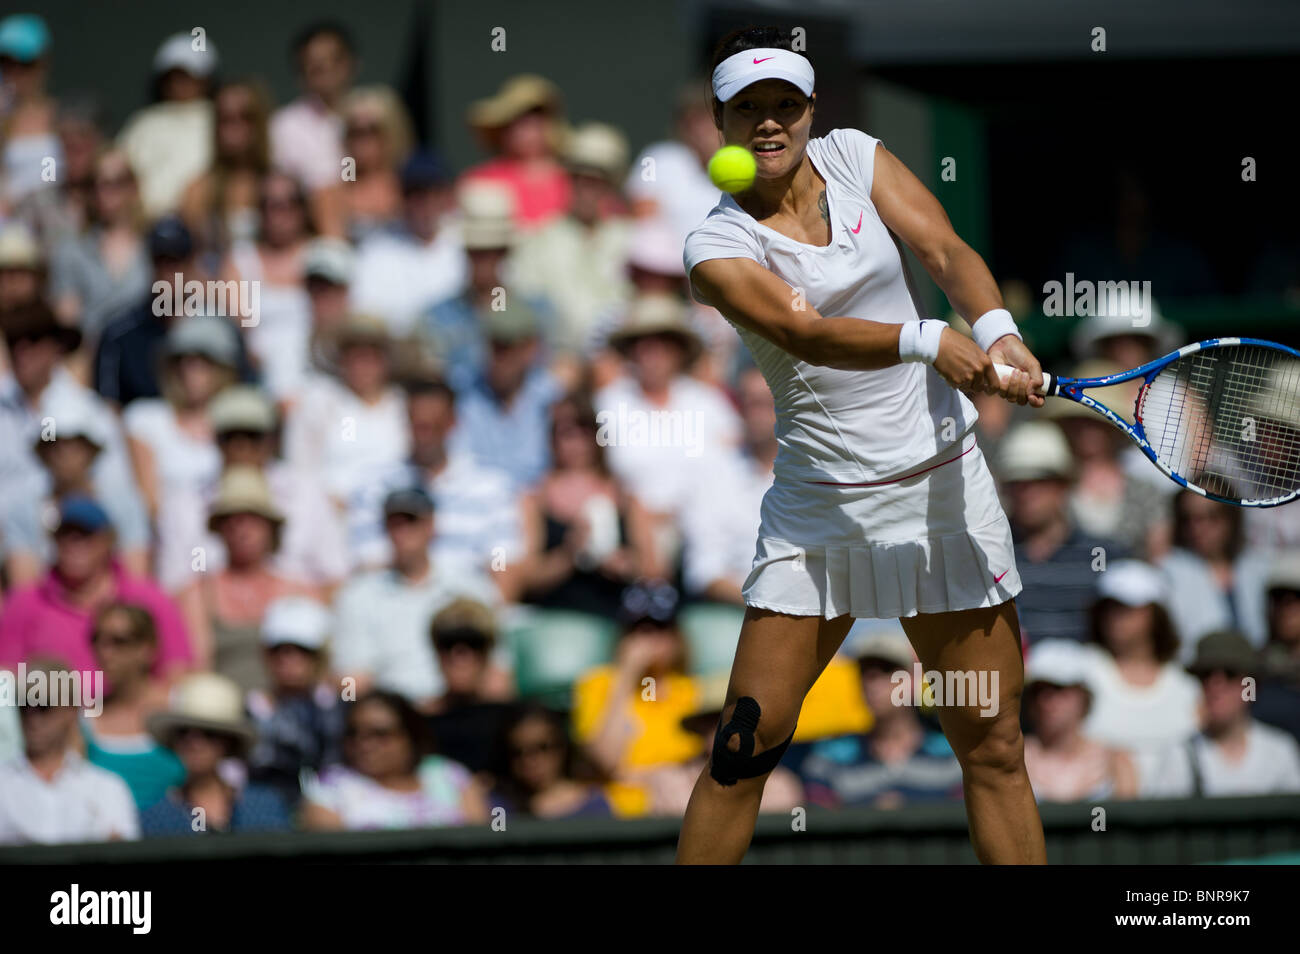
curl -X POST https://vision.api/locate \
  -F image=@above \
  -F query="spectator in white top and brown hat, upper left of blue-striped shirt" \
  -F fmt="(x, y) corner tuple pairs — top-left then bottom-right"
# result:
(285, 315), (410, 506)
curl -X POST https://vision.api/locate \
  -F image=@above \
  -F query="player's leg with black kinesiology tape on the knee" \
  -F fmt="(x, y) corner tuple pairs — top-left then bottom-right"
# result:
(677, 607), (853, 864)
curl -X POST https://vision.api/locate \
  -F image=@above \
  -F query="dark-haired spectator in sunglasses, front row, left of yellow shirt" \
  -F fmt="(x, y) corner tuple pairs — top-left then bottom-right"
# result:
(489, 704), (612, 819)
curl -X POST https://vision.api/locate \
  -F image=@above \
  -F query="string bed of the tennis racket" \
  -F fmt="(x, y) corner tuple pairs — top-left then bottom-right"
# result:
(1138, 344), (1300, 500)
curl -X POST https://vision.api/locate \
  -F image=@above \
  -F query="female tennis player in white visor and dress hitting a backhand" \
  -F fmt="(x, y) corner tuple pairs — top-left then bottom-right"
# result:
(677, 27), (1045, 863)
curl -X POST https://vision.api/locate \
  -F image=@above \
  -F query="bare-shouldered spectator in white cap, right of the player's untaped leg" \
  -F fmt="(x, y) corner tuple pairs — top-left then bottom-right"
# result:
(1021, 639), (1138, 802)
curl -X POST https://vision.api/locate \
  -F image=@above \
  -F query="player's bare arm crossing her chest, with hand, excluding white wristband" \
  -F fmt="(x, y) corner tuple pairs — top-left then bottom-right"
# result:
(690, 259), (997, 391)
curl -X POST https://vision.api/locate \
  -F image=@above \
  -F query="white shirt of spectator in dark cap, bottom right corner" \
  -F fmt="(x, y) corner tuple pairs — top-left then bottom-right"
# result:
(1138, 720), (1300, 798)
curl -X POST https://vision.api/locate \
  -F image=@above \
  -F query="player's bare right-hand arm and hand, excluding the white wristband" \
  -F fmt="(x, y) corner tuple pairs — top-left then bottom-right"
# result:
(871, 143), (1043, 406)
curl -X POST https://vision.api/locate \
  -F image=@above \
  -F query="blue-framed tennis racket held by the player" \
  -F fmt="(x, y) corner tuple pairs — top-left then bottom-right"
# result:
(996, 338), (1300, 507)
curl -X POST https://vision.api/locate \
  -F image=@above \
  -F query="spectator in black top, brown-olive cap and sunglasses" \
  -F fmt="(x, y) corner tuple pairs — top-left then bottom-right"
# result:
(426, 597), (514, 773)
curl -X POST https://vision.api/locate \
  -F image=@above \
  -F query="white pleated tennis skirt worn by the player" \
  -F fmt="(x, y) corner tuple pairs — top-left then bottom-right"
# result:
(742, 432), (1021, 619)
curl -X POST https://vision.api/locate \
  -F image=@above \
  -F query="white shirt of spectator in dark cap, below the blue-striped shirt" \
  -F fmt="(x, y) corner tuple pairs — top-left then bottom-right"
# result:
(332, 567), (501, 701)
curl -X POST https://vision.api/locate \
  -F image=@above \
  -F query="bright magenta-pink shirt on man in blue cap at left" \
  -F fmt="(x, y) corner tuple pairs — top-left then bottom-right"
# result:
(0, 564), (194, 676)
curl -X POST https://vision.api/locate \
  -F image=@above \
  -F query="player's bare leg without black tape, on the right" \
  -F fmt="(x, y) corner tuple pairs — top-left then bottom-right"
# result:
(902, 602), (1047, 864)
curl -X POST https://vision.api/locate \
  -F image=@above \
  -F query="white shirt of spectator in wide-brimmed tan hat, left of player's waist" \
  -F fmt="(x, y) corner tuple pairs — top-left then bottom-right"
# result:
(595, 374), (753, 514)
